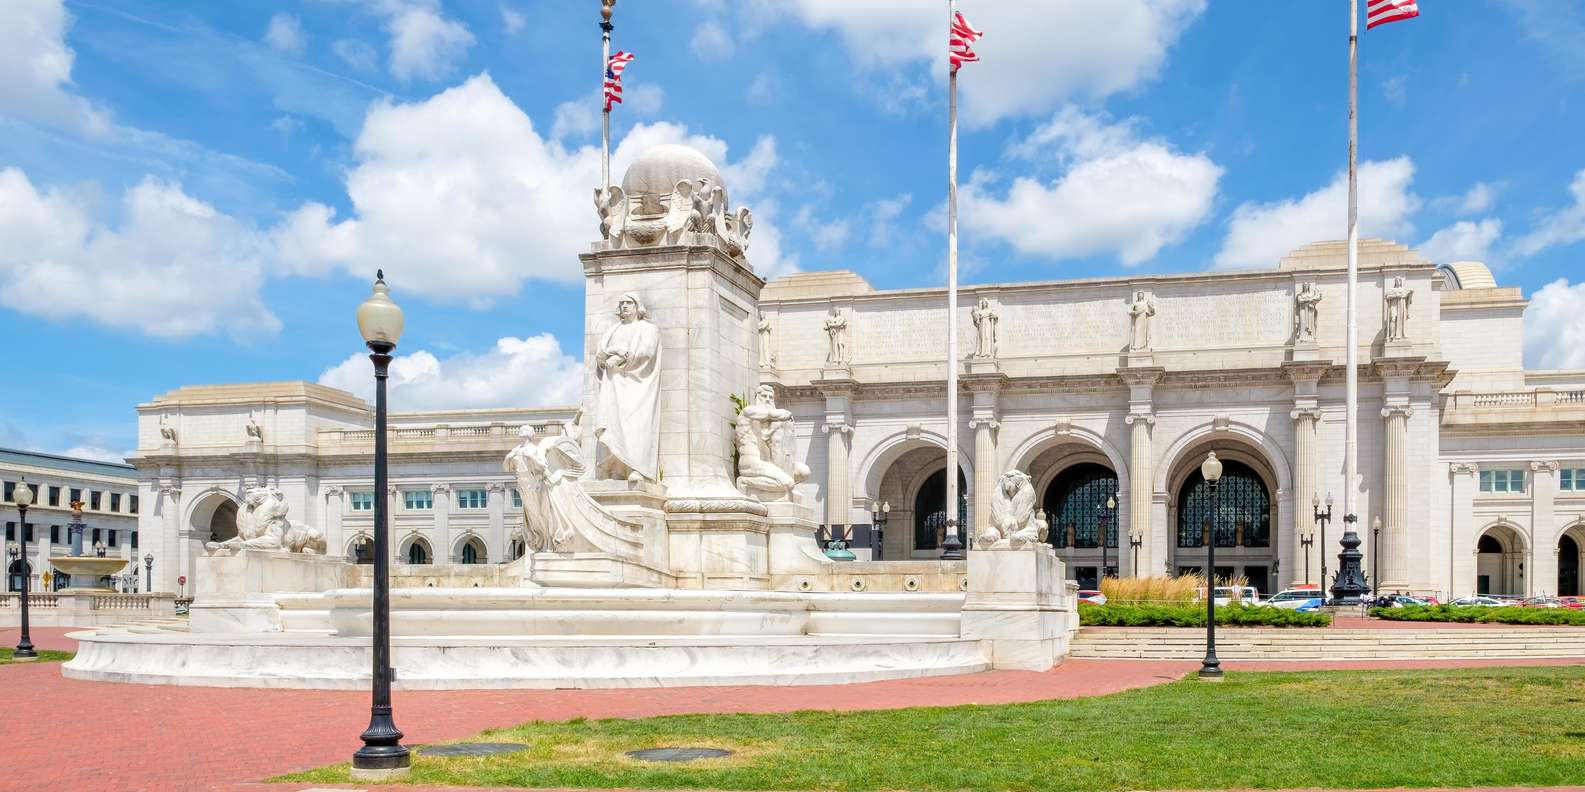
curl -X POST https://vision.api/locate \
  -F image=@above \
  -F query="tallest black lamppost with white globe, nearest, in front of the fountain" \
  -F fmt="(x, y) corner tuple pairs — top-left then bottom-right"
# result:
(352, 271), (412, 781)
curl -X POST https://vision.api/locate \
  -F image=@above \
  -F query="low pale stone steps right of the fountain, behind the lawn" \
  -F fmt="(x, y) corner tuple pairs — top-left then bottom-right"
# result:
(1070, 627), (1585, 661)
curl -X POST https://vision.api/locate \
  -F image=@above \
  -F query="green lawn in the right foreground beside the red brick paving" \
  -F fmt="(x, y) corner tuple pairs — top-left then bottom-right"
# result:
(277, 667), (1585, 790)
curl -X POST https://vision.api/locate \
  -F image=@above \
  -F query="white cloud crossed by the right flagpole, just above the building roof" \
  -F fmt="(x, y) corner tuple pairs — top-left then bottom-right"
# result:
(1216, 157), (1420, 269)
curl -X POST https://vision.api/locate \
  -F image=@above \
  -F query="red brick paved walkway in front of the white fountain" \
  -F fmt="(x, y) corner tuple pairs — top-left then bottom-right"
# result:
(0, 627), (1577, 792)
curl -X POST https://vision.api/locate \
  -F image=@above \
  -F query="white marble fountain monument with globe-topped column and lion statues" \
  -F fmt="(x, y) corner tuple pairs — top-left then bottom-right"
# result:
(63, 146), (1078, 689)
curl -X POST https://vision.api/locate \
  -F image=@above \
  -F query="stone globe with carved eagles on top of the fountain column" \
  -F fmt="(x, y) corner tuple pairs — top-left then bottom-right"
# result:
(594, 144), (754, 269)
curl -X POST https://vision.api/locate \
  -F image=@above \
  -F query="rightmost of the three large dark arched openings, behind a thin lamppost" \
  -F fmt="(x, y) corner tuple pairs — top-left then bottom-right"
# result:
(1171, 448), (1281, 594)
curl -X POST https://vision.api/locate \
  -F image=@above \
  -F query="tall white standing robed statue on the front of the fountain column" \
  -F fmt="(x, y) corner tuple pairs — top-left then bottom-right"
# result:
(594, 291), (661, 482)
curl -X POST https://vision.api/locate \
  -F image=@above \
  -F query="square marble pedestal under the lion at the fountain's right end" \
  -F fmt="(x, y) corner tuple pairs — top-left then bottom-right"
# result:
(962, 543), (1078, 672)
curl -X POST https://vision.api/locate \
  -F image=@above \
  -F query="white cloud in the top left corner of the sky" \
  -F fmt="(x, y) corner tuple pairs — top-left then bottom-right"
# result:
(0, 0), (111, 136)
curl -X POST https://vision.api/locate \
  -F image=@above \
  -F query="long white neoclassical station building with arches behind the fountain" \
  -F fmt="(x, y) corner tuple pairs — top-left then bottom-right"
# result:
(130, 241), (1585, 594)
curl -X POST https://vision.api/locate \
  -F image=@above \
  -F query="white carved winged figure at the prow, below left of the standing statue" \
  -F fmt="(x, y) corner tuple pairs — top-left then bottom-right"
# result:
(502, 409), (640, 553)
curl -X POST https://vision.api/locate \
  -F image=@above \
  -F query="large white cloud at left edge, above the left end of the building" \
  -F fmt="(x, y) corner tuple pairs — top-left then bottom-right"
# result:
(0, 168), (281, 339)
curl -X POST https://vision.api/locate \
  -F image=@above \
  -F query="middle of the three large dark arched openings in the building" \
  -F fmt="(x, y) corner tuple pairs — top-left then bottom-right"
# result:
(1040, 463), (1122, 589)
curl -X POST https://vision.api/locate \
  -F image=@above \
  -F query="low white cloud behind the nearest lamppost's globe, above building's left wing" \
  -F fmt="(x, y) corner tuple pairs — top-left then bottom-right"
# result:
(319, 333), (583, 410)
